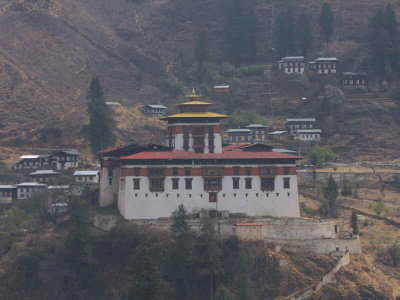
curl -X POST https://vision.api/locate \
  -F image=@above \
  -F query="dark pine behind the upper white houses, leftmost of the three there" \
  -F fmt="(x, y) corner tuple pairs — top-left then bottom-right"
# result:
(274, 8), (296, 57)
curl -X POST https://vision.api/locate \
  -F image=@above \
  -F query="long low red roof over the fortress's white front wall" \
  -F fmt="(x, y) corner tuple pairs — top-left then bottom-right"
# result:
(120, 146), (301, 159)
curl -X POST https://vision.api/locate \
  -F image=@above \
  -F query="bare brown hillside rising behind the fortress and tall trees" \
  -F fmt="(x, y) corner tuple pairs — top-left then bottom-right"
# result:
(0, 0), (399, 155)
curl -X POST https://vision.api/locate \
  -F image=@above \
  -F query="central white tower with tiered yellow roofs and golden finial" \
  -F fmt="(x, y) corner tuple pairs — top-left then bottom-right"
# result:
(162, 89), (227, 153)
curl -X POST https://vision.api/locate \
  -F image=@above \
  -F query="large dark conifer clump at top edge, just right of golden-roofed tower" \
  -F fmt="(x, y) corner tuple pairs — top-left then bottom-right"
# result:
(225, 0), (257, 63)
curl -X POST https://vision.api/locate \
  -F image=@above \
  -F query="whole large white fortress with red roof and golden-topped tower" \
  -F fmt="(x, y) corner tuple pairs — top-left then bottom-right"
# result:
(99, 93), (300, 219)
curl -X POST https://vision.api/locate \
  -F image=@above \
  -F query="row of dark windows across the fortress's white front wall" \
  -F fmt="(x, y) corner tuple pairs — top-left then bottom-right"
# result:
(126, 177), (290, 191)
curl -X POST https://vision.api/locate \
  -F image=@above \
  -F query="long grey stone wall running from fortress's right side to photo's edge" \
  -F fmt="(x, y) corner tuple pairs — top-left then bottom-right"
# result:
(297, 170), (400, 185)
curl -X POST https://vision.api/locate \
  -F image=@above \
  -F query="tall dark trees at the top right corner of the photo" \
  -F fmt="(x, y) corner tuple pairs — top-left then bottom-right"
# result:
(369, 3), (400, 80)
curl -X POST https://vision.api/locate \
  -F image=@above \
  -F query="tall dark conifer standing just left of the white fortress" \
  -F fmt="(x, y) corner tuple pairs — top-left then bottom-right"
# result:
(84, 76), (115, 151)
